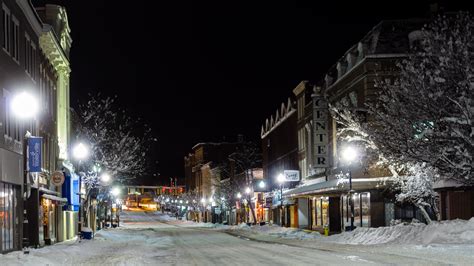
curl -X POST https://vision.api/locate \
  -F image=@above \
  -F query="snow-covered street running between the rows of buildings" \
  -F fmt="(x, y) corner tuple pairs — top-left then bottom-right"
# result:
(0, 212), (474, 265)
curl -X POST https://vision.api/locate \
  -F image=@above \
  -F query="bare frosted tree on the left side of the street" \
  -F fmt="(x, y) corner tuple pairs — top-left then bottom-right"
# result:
(75, 94), (156, 182)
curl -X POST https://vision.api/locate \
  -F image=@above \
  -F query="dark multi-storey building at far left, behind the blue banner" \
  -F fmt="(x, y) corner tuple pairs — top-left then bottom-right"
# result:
(0, 0), (69, 252)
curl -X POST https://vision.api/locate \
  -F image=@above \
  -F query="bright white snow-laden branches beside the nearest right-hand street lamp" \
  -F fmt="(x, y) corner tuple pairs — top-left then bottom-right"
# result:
(329, 99), (439, 223)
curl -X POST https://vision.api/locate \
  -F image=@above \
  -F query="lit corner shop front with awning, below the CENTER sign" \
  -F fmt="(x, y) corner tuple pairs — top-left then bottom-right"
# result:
(284, 178), (395, 233)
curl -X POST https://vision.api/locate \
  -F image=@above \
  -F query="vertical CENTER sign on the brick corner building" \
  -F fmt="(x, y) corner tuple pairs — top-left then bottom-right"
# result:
(312, 87), (329, 168)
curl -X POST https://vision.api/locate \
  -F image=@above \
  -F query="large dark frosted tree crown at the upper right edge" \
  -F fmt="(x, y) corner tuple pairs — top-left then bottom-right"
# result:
(369, 13), (474, 185)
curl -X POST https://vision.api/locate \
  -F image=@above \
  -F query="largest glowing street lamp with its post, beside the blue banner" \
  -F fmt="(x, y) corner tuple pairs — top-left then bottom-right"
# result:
(10, 91), (39, 247)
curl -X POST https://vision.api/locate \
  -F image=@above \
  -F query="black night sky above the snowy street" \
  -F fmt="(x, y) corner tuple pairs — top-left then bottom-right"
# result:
(34, 0), (469, 182)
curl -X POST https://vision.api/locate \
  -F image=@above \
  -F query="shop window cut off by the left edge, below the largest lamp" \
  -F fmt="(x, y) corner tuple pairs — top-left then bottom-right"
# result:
(0, 182), (22, 253)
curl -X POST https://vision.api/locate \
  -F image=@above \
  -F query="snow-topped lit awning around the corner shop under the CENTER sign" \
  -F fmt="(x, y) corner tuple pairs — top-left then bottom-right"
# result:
(283, 177), (393, 198)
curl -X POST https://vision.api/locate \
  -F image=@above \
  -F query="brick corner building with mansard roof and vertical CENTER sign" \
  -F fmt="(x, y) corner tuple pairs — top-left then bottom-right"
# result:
(284, 20), (423, 233)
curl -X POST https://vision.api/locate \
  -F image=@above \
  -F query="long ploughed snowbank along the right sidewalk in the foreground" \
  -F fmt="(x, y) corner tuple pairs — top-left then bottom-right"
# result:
(325, 218), (474, 245)
